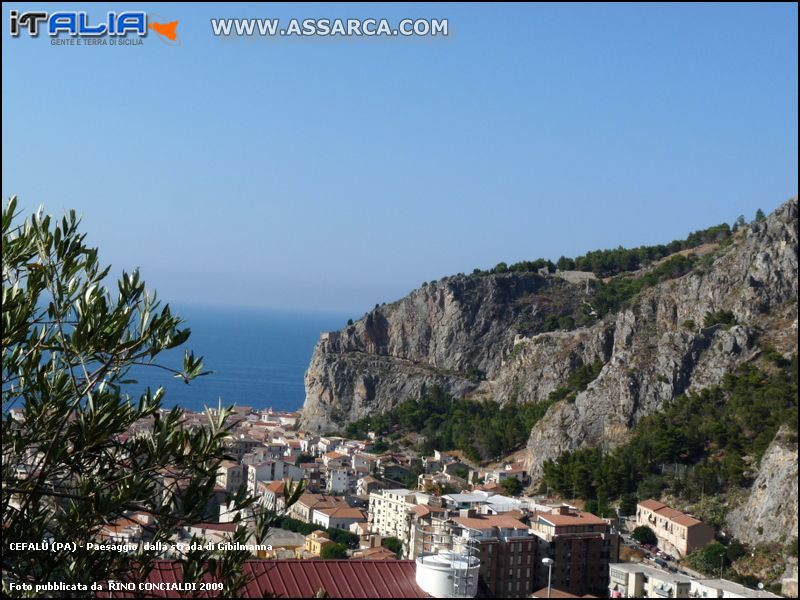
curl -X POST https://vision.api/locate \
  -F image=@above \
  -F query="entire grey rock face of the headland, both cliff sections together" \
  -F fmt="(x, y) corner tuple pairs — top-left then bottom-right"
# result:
(302, 198), (797, 476)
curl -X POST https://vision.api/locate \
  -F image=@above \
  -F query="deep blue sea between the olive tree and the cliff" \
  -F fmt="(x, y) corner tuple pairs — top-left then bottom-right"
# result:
(125, 305), (347, 410)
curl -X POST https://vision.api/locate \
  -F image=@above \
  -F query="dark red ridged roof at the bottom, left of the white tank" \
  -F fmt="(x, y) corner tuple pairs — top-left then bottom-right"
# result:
(98, 560), (429, 598)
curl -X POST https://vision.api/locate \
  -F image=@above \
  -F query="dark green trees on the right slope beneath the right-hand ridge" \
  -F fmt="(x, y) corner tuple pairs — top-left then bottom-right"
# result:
(542, 355), (797, 510)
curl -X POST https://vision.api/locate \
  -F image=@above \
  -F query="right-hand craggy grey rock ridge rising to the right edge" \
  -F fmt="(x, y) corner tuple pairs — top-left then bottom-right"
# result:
(528, 199), (797, 478)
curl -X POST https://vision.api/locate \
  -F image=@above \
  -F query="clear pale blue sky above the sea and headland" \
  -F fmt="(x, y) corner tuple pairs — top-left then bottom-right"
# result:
(2, 2), (798, 316)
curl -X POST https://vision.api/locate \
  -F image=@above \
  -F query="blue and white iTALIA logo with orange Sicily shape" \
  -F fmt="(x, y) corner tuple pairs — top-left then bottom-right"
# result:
(9, 10), (178, 42)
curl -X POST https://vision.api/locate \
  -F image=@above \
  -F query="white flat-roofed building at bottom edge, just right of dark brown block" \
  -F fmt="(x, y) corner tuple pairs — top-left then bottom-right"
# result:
(608, 563), (692, 598)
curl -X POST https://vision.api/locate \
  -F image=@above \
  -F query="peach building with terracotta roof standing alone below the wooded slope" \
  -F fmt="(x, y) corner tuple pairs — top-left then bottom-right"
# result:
(636, 498), (714, 557)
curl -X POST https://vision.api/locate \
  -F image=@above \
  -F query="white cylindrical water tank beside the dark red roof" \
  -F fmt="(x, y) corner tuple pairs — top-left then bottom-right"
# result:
(416, 552), (481, 598)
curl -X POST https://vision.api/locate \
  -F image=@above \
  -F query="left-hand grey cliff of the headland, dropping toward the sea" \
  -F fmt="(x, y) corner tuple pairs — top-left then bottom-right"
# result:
(301, 273), (582, 431)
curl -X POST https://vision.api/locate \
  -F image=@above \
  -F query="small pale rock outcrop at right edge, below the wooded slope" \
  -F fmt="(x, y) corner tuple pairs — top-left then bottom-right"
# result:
(727, 428), (797, 548)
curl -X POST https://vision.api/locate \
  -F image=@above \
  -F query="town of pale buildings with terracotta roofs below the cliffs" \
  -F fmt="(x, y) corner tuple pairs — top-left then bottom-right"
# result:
(12, 406), (797, 598)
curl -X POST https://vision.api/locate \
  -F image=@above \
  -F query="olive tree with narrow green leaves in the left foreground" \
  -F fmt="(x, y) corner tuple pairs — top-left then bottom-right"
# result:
(2, 198), (302, 595)
